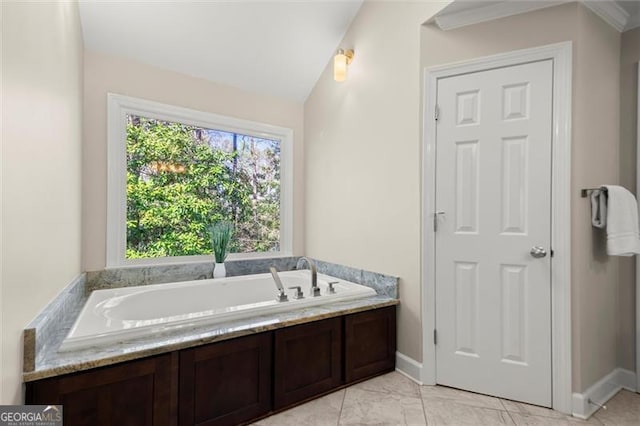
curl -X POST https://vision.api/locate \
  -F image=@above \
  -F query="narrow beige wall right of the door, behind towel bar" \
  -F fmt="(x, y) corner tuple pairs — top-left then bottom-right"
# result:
(571, 6), (620, 391)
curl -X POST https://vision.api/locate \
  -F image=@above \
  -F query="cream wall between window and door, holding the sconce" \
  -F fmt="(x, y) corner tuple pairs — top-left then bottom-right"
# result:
(304, 2), (443, 361)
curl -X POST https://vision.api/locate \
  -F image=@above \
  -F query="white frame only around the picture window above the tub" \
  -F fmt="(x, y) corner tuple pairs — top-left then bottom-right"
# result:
(106, 93), (293, 268)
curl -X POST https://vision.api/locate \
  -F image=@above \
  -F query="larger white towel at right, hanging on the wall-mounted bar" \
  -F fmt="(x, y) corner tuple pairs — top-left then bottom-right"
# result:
(605, 185), (640, 256)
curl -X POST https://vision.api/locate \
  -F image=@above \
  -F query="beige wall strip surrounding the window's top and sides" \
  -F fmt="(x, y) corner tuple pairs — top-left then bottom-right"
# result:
(82, 51), (304, 271)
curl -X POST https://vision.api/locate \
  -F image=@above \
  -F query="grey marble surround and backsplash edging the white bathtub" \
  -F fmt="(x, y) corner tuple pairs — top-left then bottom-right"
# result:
(23, 256), (399, 381)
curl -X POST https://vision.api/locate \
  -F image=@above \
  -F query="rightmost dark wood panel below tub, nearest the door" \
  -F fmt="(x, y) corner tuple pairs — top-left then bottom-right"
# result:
(344, 306), (396, 383)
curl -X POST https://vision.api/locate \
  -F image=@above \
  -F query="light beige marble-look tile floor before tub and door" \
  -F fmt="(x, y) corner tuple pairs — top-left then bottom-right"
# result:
(254, 372), (640, 426)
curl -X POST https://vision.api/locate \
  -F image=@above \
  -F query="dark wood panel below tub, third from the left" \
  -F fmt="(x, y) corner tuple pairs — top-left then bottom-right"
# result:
(273, 318), (342, 410)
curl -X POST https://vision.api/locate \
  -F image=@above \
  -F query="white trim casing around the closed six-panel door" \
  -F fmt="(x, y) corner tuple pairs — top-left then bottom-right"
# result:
(421, 41), (572, 414)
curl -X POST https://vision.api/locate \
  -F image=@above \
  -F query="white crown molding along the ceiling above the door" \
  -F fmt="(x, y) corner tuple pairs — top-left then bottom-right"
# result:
(432, 0), (640, 32)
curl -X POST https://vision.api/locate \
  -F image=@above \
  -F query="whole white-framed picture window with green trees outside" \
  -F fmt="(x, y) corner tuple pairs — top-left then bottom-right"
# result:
(107, 94), (293, 267)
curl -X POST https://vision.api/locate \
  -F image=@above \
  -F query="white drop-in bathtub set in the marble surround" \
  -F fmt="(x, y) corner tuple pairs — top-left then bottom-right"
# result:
(59, 270), (376, 351)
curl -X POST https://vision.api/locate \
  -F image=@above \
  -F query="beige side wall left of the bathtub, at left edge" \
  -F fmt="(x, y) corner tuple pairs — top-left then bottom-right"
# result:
(0, 2), (83, 404)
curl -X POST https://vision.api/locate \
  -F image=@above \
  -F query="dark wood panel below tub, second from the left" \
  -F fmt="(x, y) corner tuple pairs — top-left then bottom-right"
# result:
(179, 332), (273, 426)
